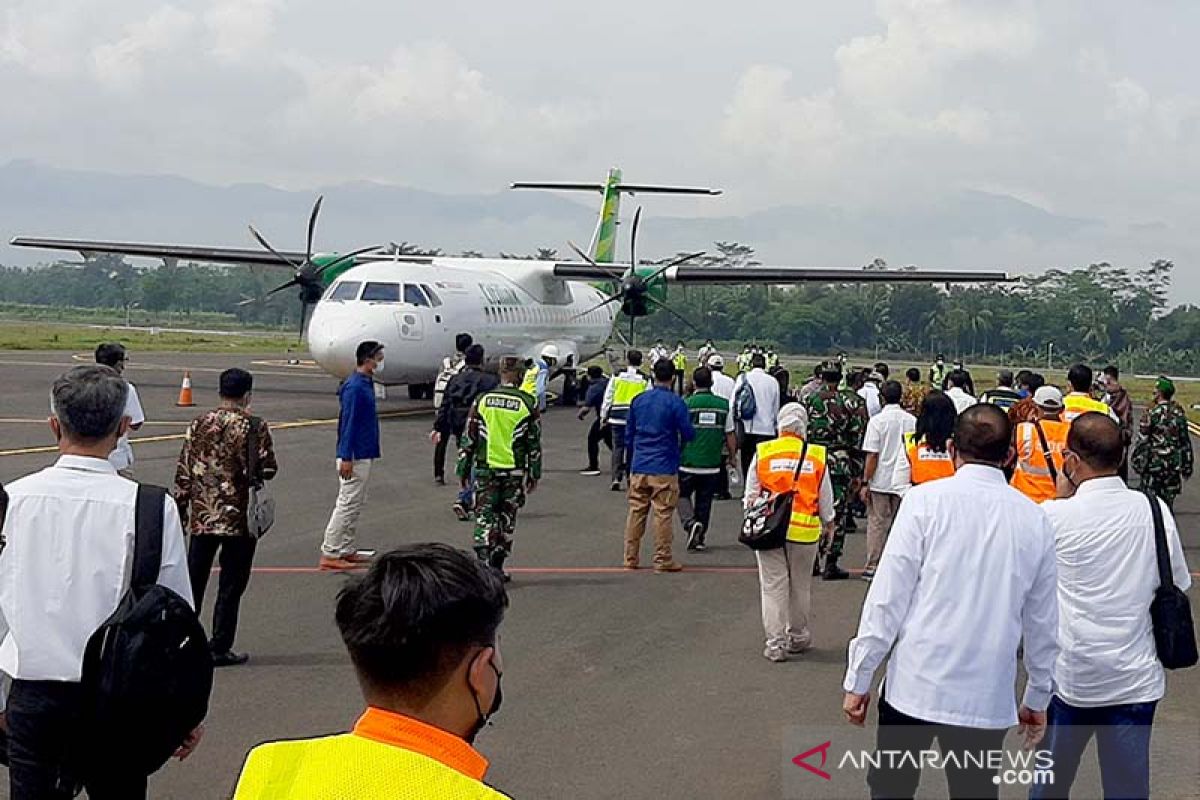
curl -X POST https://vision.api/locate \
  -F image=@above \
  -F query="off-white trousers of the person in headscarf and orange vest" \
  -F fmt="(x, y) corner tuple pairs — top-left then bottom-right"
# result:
(755, 542), (817, 648)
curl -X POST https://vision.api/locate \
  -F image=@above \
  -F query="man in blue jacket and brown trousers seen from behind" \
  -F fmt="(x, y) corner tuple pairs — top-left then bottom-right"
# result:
(624, 360), (696, 572)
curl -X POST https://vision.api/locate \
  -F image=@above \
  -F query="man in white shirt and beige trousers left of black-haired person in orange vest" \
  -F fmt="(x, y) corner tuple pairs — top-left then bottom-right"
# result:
(860, 380), (917, 581)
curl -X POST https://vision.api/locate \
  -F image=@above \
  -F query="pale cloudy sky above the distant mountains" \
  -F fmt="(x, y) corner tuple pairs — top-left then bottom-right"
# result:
(0, 0), (1200, 297)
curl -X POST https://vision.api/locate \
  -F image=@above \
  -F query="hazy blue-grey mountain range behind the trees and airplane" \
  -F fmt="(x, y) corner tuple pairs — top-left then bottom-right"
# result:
(0, 161), (1180, 301)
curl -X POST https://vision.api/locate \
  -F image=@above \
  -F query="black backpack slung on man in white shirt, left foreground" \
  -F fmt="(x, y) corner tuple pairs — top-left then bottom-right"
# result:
(74, 486), (212, 775)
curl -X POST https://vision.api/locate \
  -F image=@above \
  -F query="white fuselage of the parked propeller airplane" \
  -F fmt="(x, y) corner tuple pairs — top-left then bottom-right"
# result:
(307, 258), (617, 384)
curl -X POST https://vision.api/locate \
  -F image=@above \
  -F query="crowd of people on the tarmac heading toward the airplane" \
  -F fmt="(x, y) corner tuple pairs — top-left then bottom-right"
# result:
(0, 335), (1193, 800)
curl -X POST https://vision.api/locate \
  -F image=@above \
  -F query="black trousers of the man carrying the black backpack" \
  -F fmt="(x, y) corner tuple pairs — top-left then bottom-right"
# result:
(7, 680), (146, 800)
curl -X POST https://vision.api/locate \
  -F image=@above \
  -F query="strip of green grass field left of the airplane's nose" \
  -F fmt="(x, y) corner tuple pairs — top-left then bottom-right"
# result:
(0, 319), (304, 354)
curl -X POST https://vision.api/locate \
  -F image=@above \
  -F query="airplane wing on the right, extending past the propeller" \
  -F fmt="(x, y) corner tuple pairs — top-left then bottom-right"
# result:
(554, 261), (1015, 285)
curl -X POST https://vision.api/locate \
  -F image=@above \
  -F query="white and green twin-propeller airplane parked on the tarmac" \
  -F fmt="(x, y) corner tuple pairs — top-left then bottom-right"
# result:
(10, 168), (1009, 399)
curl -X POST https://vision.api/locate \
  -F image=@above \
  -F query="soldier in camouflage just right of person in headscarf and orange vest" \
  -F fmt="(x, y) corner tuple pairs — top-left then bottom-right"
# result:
(803, 363), (866, 581)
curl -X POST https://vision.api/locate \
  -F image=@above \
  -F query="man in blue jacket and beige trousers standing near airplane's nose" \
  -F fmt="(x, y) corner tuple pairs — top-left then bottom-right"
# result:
(319, 341), (383, 570)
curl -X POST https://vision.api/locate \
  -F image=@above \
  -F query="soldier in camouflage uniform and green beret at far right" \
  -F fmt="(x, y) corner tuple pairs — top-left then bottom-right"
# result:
(1130, 378), (1194, 507)
